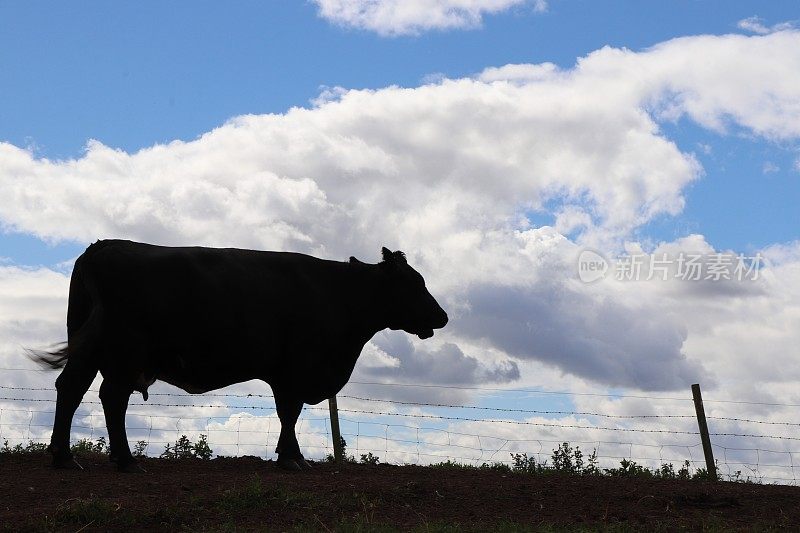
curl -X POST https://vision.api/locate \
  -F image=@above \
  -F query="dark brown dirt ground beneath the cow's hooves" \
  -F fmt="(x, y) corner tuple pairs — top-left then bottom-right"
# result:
(0, 454), (800, 531)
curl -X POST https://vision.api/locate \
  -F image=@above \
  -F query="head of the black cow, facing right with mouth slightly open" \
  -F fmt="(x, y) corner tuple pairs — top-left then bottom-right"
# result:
(378, 248), (447, 339)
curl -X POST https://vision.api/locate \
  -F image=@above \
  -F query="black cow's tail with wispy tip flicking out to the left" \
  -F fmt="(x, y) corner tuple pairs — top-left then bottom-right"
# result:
(25, 250), (100, 369)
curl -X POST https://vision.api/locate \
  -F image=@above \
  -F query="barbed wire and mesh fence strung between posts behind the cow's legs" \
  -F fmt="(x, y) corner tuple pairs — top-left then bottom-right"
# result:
(0, 369), (800, 485)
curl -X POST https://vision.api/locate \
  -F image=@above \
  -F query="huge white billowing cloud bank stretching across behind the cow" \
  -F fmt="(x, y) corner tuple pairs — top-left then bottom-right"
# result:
(0, 31), (800, 389)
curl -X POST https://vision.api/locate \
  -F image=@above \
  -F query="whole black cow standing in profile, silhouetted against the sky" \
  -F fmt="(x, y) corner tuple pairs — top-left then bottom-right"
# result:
(31, 240), (447, 471)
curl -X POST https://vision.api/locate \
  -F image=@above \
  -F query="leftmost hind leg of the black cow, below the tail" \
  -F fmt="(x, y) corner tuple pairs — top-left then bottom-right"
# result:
(48, 359), (97, 469)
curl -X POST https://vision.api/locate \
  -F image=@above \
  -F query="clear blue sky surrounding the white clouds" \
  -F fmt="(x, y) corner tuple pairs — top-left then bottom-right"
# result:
(0, 0), (800, 264)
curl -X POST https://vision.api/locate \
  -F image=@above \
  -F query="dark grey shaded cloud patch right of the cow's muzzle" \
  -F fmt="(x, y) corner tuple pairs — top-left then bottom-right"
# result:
(458, 285), (710, 390)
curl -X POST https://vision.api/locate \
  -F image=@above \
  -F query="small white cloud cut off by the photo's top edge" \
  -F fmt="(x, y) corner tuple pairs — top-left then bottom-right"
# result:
(314, 0), (547, 35)
